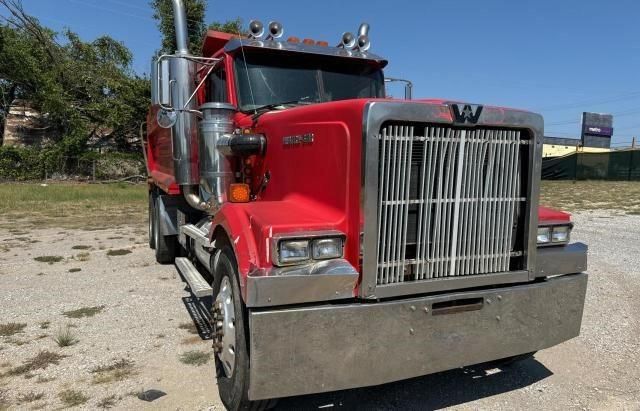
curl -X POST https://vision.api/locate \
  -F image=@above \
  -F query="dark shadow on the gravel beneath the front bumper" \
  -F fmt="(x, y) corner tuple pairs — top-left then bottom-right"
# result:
(276, 358), (553, 411)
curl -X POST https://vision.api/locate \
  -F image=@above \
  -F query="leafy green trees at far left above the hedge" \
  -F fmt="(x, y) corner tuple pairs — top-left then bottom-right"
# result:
(0, 0), (150, 156)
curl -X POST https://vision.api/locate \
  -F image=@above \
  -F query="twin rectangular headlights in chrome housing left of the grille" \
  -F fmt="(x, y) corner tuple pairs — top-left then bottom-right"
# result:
(272, 231), (345, 266)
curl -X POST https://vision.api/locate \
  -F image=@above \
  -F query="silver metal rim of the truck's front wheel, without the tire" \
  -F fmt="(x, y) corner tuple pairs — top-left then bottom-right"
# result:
(214, 277), (236, 378)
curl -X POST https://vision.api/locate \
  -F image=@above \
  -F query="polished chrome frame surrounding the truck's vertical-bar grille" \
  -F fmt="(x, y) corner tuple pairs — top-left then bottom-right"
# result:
(360, 101), (544, 298)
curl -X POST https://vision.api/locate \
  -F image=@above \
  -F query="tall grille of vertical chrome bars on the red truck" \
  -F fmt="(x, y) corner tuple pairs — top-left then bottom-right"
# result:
(377, 125), (529, 285)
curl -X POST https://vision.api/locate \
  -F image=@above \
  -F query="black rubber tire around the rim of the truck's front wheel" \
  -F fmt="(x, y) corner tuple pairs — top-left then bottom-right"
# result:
(213, 247), (276, 411)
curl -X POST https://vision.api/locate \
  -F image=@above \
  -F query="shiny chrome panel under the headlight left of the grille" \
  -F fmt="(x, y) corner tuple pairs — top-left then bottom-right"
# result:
(244, 258), (358, 307)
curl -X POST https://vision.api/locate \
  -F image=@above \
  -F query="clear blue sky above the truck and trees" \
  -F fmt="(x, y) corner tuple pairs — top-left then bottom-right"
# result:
(12, 0), (640, 146)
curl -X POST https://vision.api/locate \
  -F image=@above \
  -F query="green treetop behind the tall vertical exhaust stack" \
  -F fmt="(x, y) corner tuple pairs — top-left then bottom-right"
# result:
(150, 0), (206, 56)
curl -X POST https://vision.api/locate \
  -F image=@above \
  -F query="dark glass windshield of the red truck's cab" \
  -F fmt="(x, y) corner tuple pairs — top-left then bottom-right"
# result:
(235, 53), (384, 111)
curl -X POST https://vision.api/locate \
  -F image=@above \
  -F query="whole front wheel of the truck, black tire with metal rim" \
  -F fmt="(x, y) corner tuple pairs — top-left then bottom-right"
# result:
(212, 248), (275, 411)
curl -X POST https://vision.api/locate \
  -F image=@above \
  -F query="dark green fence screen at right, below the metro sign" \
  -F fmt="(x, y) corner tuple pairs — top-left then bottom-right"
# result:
(542, 150), (640, 181)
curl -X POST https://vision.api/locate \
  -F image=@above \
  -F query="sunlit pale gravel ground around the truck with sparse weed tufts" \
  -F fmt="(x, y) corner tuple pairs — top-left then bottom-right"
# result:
(0, 210), (640, 410)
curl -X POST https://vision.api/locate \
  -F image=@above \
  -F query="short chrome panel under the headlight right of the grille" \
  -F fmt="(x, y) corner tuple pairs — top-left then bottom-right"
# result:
(536, 243), (589, 277)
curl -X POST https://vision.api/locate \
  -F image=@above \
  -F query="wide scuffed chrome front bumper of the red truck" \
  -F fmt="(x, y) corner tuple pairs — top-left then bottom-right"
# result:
(249, 274), (587, 400)
